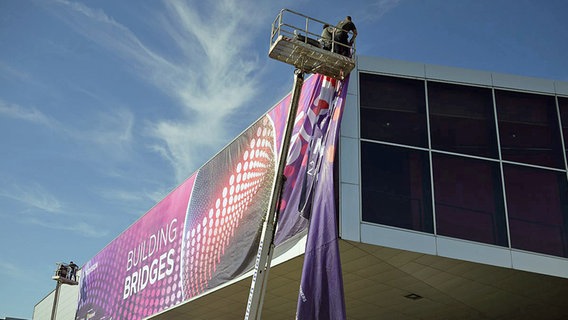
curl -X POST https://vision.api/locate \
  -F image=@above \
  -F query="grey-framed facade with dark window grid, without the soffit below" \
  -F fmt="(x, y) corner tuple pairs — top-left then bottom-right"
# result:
(341, 57), (568, 277)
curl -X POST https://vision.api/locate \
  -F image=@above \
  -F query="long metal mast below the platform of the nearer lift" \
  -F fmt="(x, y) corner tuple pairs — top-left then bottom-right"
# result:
(245, 69), (304, 320)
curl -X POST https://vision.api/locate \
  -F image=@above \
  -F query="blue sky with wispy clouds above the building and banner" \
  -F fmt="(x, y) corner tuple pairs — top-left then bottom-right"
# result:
(0, 0), (568, 319)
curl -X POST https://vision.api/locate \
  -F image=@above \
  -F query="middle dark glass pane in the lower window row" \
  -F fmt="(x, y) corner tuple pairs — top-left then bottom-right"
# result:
(432, 153), (509, 246)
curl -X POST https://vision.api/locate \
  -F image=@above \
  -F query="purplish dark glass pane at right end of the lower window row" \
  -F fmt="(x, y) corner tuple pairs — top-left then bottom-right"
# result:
(504, 164), (568, 257)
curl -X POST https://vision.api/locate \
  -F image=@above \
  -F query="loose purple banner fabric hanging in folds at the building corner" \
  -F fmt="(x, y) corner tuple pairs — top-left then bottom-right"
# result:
(296, 74), (349, 320)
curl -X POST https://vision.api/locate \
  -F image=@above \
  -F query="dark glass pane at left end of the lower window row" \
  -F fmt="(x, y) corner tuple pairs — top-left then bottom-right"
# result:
(361, 142), (434, 233)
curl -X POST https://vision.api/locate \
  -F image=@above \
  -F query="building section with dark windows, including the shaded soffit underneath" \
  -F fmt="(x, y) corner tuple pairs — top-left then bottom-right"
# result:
(332, 56), (568, 319)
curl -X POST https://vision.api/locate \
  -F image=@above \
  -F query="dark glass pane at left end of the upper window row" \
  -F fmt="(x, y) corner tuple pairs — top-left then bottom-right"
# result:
(359, 73), (428, 147)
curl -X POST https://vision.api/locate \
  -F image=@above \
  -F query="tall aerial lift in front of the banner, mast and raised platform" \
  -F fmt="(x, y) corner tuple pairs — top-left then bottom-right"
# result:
(244, 9), (355, 320)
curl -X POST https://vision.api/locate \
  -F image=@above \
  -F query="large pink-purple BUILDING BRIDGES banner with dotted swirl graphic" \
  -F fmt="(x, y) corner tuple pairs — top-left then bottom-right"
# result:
(76, 75), (350, 319)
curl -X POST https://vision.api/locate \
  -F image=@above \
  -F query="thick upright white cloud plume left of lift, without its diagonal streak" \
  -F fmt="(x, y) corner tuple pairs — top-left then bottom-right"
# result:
(153, 1), (272, 180)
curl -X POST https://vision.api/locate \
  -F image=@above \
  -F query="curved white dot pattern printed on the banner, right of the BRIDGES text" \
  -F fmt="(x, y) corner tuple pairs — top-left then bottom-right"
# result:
(182, 117), (275, 299)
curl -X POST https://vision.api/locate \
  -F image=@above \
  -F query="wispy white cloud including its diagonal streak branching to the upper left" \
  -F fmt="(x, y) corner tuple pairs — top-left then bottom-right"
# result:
(50, 0), (276, 181)
